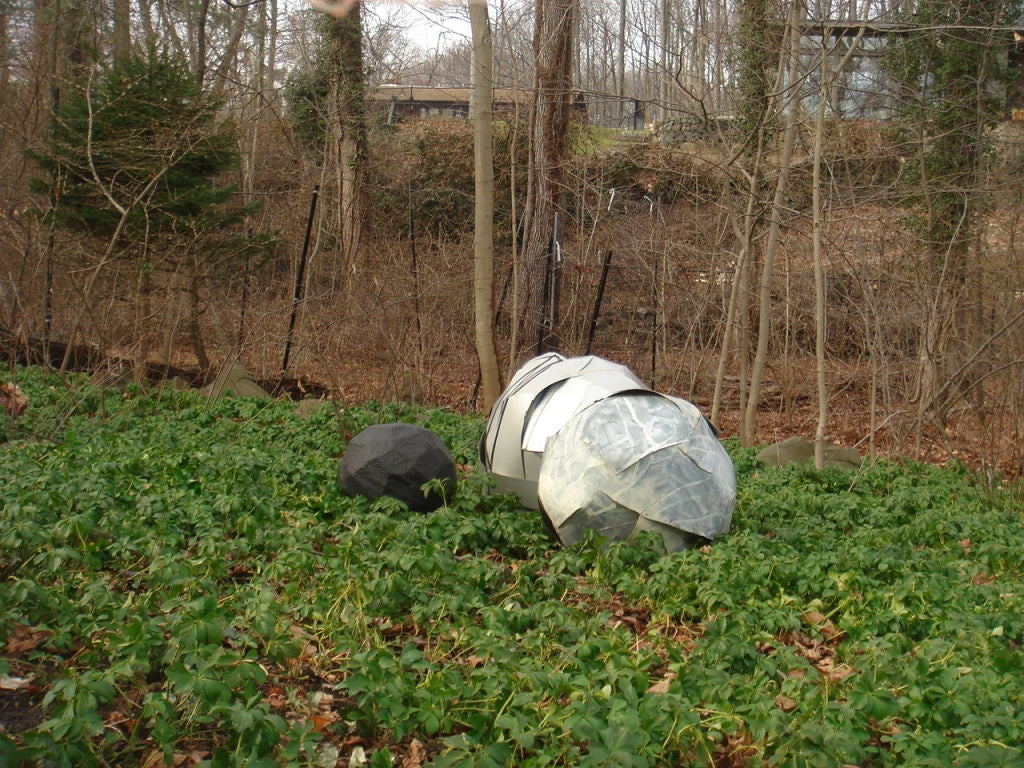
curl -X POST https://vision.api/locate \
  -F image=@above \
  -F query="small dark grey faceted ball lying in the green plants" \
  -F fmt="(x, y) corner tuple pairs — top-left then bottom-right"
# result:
(338, 423), (456, 512)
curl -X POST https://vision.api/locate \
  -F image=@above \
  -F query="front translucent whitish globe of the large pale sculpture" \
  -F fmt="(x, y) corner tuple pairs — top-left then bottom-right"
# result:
(538, 392), (736, 552)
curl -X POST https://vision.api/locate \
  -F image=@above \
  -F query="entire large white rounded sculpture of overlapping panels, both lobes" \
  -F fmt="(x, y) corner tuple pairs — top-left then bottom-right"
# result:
(480, 352), (736, 552)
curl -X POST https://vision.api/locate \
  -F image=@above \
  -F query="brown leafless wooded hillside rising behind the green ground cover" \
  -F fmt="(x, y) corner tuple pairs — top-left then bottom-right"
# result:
(0, 0), (1024, 474)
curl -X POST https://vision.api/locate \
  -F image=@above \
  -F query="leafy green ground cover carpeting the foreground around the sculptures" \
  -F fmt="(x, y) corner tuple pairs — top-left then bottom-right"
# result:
(0, 369), (1024, 768)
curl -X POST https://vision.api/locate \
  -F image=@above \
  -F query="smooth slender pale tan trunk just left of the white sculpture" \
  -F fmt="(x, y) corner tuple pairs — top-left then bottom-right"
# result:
(469, 2), (502, 411)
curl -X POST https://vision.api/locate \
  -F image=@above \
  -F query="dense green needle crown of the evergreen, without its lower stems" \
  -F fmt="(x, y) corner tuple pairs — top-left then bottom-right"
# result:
(33, 52), (260, 256)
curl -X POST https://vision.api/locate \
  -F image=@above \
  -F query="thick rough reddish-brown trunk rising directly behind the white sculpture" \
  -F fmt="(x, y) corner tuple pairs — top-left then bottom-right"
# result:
(519, 0), (575, 364)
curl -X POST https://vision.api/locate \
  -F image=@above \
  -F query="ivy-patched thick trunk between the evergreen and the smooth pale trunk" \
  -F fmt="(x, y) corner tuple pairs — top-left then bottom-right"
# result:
(327, 2), (367, 265)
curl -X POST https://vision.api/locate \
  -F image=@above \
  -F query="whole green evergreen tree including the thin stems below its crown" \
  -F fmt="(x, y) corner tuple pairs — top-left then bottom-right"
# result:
(32, 50), (271, 379)
